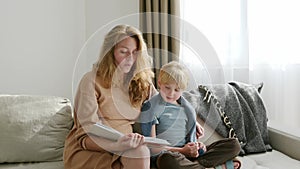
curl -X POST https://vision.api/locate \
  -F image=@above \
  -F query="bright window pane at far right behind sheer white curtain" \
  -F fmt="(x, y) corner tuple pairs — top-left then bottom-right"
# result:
(248, 0), (300, 67)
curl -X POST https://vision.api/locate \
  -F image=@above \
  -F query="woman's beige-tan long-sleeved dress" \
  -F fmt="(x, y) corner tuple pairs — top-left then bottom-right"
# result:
(64, 71), (155, 169)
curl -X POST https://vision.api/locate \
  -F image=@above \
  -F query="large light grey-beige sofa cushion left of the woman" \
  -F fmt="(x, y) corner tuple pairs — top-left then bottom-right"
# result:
(0, 95), (73, 163)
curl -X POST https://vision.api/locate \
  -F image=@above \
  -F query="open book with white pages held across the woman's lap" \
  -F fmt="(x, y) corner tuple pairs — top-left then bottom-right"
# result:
(88, 123), (170, 146)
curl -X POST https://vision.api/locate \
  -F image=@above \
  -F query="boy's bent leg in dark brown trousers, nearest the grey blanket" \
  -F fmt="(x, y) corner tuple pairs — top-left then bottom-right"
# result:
(197, 138), (241, 168)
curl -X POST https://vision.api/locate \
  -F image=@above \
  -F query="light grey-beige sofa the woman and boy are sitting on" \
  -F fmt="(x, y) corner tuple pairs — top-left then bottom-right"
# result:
(0, 95), (300, 169)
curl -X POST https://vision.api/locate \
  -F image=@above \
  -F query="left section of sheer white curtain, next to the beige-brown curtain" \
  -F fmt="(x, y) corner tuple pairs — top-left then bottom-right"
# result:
(180, 0), (250, 86)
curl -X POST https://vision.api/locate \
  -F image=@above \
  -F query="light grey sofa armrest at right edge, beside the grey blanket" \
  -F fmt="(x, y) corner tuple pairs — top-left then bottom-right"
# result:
(268, 126), (300, 160)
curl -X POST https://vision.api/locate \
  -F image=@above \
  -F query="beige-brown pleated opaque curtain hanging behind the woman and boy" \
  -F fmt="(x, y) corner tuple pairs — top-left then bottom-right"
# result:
(140, 0), (180, 85)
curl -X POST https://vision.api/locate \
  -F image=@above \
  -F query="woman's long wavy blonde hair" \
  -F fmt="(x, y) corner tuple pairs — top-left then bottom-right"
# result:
(93, 25), (154, 107)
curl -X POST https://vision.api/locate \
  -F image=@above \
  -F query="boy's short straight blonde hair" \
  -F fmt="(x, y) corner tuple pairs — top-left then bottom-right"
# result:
(158, 61), (189, 90)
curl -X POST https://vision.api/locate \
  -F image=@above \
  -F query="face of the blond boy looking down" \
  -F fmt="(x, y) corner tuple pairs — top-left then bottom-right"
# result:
(158, 81), (182, 104)
